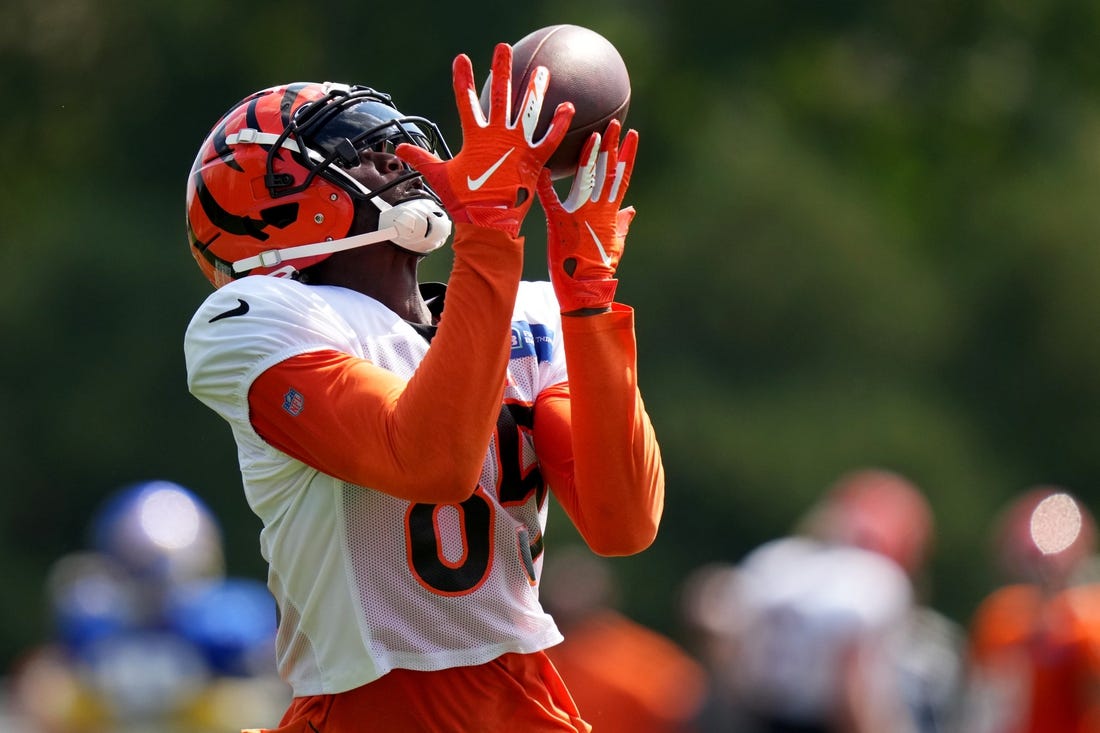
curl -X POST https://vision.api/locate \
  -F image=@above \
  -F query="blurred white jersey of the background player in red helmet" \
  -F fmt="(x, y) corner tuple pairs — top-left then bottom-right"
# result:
(733, 537), (912, 723)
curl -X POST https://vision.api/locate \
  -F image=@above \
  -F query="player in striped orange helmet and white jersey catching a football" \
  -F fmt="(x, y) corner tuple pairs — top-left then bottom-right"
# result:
(185, 44), (663, 733)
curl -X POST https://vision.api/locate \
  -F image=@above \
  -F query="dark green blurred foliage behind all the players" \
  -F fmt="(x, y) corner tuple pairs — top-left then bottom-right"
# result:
(0, 0), (1100, 669)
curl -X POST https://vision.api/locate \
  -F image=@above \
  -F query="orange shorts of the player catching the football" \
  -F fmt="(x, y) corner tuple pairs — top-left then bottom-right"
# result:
(247, 652), (592, 733)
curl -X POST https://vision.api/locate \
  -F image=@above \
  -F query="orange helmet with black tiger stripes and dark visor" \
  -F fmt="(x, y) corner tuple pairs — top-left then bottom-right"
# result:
(187, 83), (451, 287)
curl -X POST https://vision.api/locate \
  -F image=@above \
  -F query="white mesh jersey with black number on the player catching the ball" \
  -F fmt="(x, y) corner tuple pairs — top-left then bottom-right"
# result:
(185, 272), (567, 696)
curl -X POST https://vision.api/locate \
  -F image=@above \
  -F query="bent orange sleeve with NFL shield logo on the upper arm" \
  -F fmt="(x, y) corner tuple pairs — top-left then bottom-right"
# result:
(249, 223), (523, 503)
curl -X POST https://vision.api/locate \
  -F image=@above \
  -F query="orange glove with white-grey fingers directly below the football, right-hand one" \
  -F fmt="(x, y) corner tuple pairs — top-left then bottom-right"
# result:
(538, 120), (638, 314)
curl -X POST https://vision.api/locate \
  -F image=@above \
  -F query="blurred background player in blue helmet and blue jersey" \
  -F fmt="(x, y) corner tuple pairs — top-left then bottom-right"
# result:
(12, 481), (289, 733)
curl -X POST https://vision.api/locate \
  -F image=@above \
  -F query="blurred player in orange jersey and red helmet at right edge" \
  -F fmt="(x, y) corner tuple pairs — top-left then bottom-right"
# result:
(965, 485), (1100, 733)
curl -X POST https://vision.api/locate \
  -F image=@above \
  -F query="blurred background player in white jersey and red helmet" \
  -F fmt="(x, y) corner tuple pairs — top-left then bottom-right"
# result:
(729, 469), (958, 733)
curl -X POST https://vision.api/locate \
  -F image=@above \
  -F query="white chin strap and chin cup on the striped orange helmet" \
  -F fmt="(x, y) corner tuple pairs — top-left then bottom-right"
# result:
(233, 197), (451, 273)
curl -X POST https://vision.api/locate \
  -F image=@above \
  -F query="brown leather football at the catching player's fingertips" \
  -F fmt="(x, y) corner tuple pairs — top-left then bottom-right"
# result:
(481, 24), (630, 179)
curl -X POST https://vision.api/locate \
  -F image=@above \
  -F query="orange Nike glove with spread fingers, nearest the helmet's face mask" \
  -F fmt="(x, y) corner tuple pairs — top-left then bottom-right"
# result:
(395, 43), (573, 237)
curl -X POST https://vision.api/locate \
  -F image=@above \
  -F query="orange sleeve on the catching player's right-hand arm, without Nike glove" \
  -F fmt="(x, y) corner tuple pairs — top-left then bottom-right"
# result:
(535, 305), (664, 555)
